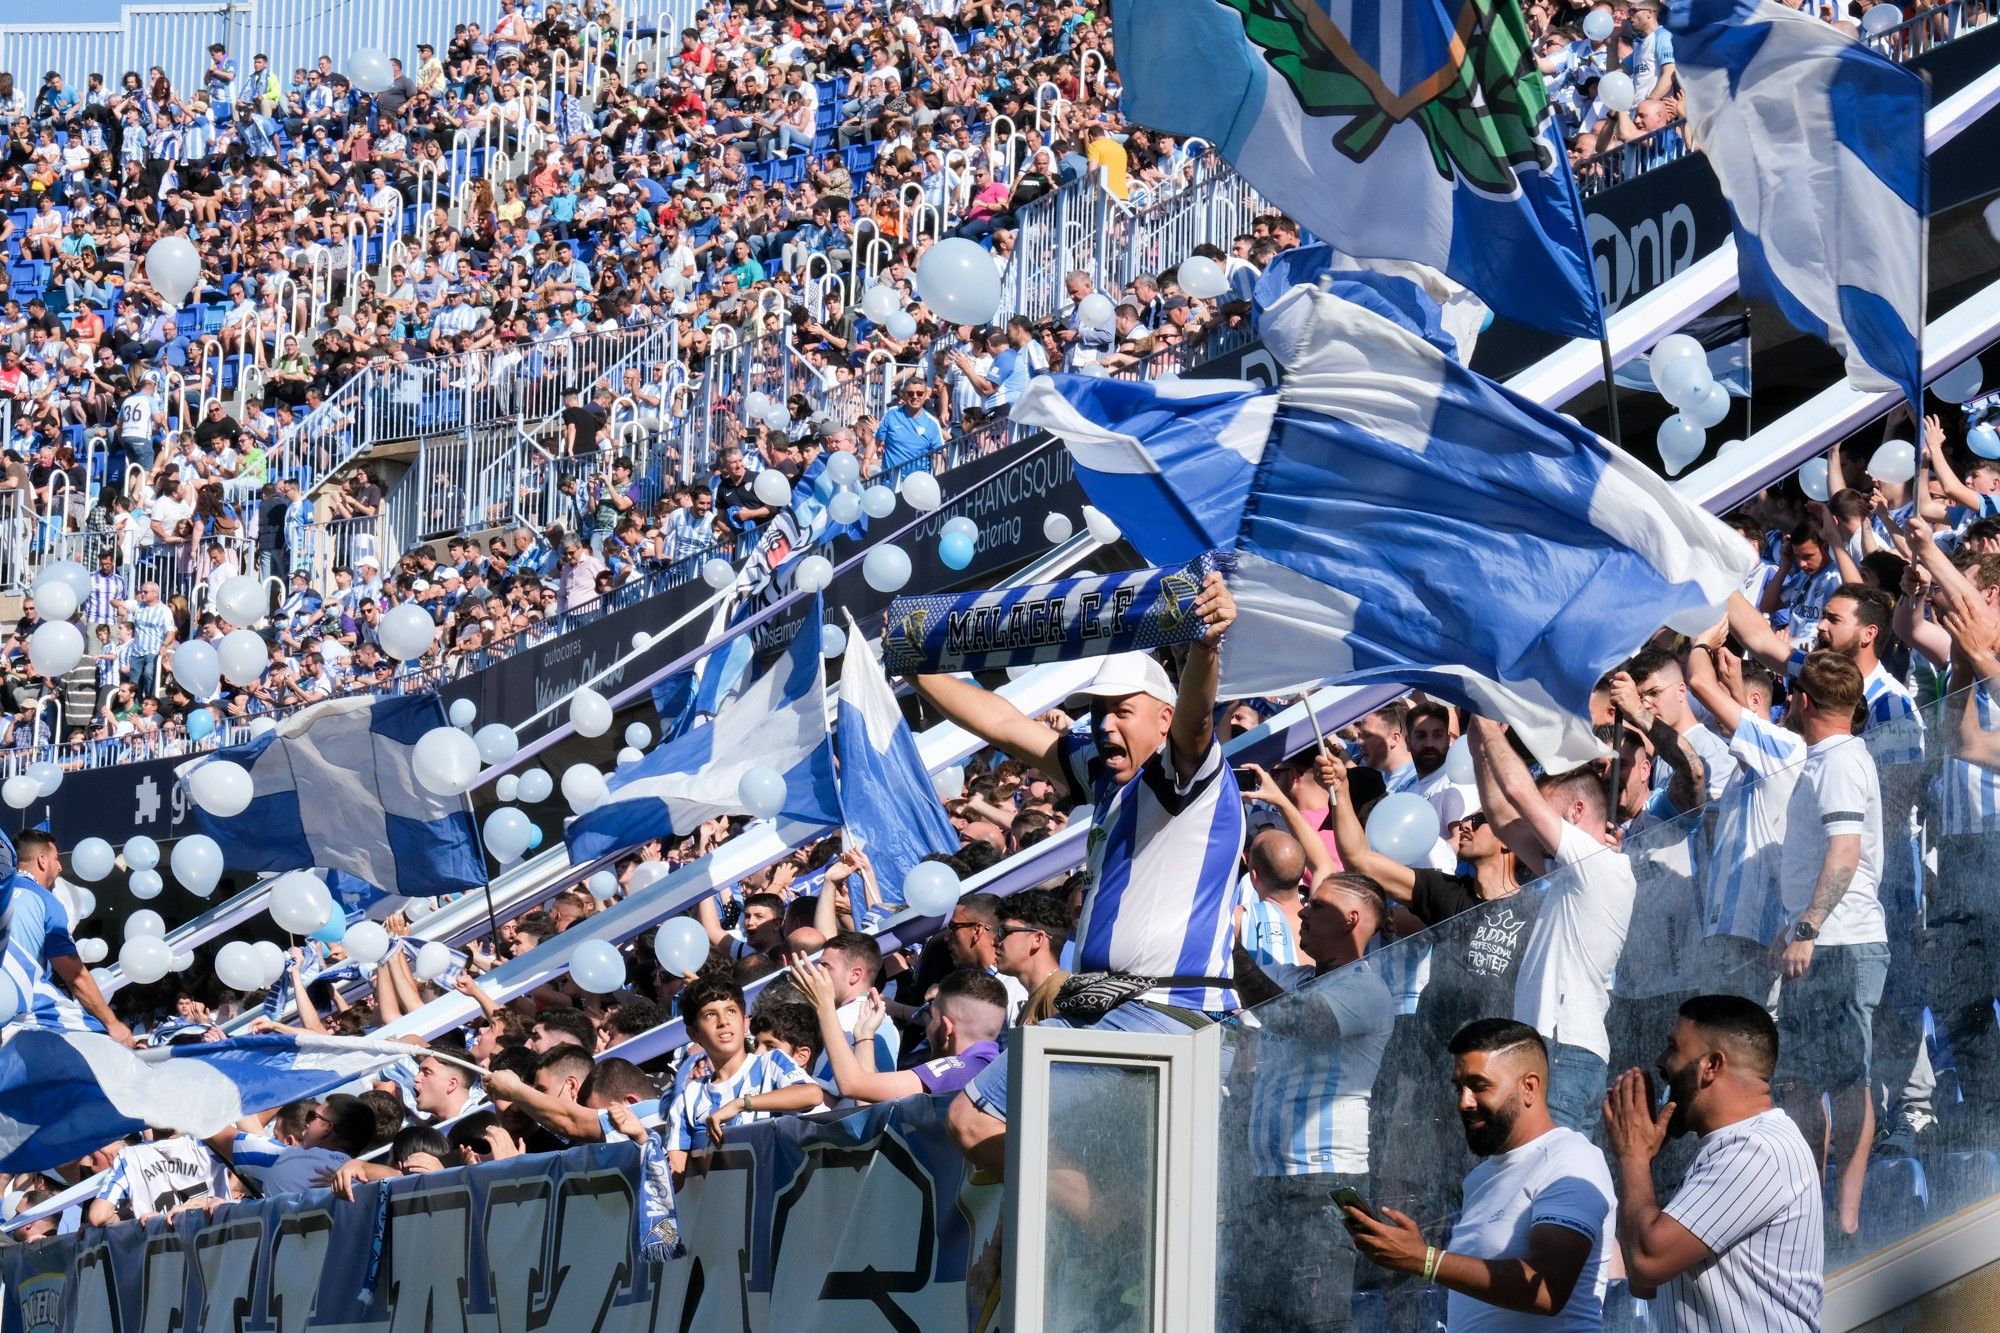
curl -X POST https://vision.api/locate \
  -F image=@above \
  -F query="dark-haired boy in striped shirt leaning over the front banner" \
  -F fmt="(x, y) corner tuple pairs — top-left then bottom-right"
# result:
(662, 964), (826, 1179)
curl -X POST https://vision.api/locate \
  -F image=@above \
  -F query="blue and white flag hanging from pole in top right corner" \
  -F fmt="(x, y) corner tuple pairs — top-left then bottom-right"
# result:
(1666, 0), (1930, 414)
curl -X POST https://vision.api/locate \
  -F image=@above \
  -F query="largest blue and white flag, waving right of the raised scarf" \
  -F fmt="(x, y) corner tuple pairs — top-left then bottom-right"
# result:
(1222, 288), (1754, 769)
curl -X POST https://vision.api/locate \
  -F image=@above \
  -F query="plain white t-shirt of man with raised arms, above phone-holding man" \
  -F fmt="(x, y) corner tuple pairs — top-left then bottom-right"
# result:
(1514, 823), (1638, 1061)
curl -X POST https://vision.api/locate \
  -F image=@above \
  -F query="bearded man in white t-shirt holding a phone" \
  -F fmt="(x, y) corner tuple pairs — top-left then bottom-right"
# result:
(1346, 1019), (1612, 1333)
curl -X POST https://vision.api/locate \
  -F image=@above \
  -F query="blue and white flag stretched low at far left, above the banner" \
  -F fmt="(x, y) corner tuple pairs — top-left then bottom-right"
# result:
(0, 1029), (422, 1173)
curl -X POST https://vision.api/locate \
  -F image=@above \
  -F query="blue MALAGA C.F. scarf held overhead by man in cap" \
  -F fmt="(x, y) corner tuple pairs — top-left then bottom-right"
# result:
(882, 552), (1224, 677)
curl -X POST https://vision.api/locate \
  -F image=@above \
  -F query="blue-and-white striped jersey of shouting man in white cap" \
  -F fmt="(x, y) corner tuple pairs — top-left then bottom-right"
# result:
(1056, 735), (1244, 1011)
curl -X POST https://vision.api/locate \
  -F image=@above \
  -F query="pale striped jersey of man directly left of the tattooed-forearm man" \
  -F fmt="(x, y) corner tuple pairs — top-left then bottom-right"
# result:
(1702, 709), (1806, 945)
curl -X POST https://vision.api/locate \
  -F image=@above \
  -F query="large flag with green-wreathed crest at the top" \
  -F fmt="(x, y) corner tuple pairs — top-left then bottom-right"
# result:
(1112, 0), (1604, 338)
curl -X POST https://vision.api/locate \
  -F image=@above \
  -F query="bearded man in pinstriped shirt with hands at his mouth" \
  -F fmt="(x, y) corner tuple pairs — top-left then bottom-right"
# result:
(1604, 995), (1826, 1333)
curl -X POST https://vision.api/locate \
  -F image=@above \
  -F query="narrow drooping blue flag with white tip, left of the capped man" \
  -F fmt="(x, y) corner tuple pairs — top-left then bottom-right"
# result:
(836, 616), (958, 908)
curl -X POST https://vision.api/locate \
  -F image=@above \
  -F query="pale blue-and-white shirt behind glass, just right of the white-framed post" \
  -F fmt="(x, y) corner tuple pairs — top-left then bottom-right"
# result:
(1250, 961), (1396, 1175)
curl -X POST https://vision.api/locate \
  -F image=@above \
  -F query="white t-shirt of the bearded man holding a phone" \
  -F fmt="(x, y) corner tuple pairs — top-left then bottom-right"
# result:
(1444, 1120), (1616, 1333)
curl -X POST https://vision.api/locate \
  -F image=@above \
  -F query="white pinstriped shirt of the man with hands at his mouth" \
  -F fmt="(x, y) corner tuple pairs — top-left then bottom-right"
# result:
(1652, 1111), (1826, 1333)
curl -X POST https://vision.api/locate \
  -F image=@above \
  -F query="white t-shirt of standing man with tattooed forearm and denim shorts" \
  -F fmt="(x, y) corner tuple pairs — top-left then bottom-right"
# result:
(1778, 737), (1888, 947)
